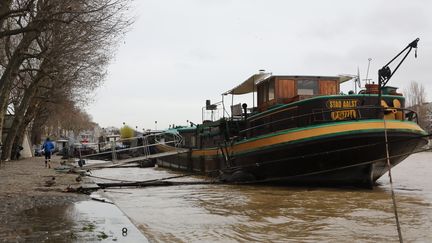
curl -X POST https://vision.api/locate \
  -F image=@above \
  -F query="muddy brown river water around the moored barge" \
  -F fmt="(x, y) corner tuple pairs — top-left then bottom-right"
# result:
(93, 153), (432, 242)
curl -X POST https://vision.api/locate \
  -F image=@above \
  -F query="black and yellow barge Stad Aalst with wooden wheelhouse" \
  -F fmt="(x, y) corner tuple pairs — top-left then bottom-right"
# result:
(157, 39), (427, 187)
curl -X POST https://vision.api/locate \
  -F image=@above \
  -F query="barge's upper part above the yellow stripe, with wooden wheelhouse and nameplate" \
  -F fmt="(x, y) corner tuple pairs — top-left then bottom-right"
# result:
(224, 73), (405, 138)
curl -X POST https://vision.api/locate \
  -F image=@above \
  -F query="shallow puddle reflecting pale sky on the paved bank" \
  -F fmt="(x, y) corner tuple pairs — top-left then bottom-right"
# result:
(15, 198), (147, 243)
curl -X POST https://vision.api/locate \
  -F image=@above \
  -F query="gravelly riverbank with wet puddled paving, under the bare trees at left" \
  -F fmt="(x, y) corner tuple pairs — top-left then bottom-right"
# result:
(0, 157), (146, 242)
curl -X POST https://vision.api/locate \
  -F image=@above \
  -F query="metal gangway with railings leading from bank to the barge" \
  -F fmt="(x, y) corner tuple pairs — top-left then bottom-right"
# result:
(80, 132), (189, 168)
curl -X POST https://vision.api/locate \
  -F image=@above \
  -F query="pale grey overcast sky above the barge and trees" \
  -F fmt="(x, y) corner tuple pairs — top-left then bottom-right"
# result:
(87, 0), (432, 130)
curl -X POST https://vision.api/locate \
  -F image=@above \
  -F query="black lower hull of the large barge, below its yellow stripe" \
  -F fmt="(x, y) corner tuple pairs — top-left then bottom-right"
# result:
(158, 131), (427, 187)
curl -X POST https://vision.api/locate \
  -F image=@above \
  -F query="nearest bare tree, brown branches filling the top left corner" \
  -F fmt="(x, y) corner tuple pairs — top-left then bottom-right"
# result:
(0, 0), (131, 159)
